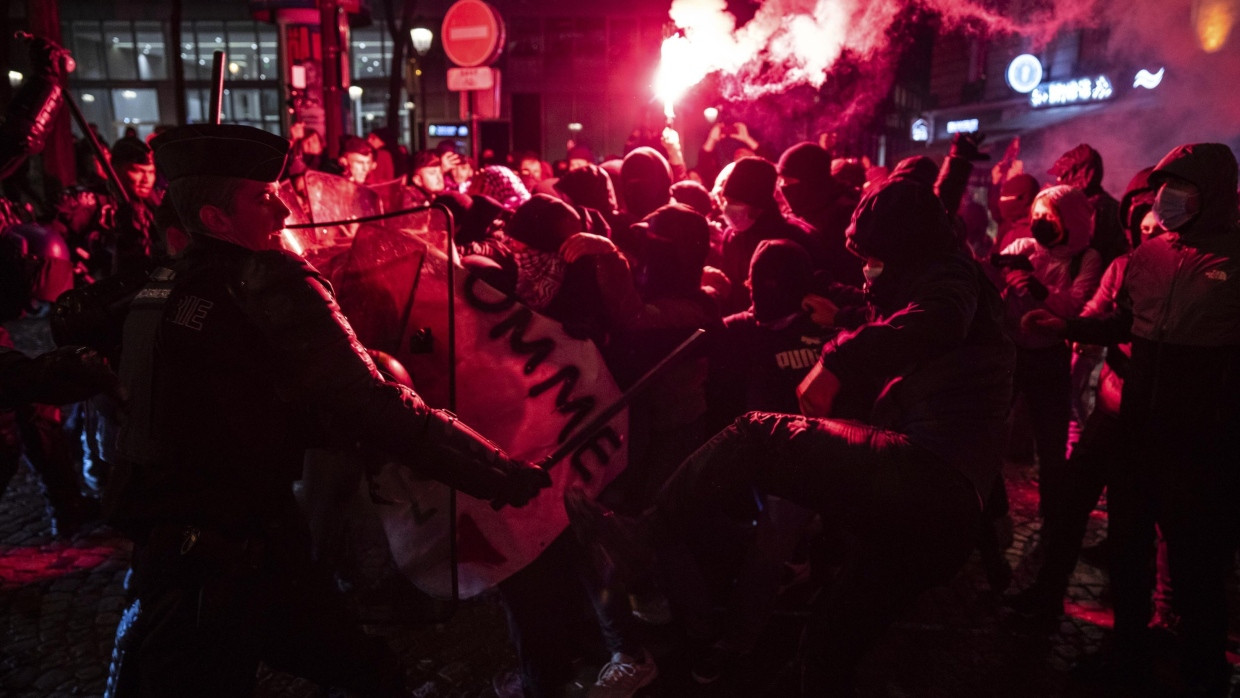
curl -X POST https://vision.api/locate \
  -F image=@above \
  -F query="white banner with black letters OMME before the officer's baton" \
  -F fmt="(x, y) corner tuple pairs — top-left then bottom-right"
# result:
(331, 204), (627, 598)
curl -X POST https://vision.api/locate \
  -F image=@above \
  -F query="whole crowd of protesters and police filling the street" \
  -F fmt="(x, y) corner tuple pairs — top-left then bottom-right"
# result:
(0, 36), (1240, 697)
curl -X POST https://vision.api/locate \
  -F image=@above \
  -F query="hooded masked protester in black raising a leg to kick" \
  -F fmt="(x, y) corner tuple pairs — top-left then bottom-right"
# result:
(605, 177), (1012, 694)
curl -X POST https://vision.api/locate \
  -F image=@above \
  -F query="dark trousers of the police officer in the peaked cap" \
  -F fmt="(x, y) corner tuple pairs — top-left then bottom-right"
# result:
(107, 496), (403, 698)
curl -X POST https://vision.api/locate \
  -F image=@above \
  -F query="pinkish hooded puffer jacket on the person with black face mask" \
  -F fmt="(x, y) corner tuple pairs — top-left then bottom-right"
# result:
(1003, 185), (1102, 348)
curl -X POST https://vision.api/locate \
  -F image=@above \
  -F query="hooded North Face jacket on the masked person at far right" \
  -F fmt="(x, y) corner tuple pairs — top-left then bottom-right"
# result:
(1068, 144), (1240, 453)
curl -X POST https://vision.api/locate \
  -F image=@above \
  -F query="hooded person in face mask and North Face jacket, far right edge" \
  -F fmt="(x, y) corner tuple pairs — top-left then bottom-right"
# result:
(1025, 143), (1240, 696)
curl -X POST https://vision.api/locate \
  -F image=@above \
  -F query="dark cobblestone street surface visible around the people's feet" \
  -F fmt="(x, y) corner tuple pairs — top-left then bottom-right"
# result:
(0, 465), (1240, 698)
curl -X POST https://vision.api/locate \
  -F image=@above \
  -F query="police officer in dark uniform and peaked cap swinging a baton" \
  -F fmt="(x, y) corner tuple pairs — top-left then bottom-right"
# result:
(104, 125), (549, 696)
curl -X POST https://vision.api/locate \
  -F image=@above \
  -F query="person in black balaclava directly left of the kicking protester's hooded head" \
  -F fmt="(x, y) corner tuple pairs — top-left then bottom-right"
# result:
(779, 143), (864, 288)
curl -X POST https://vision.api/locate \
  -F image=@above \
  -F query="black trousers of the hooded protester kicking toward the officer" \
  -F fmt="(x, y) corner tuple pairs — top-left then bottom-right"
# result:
(657, 413), (981, 696)
